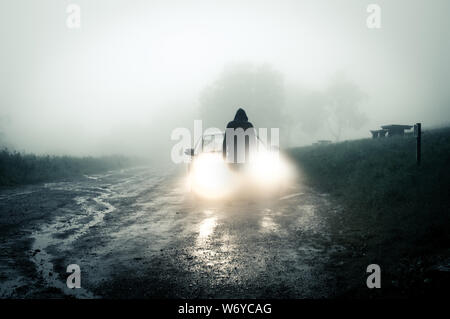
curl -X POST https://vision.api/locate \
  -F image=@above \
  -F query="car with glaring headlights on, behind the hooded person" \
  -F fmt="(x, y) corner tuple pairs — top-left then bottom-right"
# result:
(185, 131), (292, 199)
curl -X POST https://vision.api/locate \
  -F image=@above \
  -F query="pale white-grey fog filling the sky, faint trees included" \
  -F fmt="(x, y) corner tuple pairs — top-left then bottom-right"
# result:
(0, 0), (450, 160)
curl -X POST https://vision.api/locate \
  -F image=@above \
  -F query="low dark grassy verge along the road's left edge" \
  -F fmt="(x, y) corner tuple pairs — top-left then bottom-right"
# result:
(0, 149), (132, 186)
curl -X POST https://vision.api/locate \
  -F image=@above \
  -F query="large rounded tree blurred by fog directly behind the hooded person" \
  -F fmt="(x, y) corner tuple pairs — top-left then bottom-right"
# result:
(200, 63), (284, 134)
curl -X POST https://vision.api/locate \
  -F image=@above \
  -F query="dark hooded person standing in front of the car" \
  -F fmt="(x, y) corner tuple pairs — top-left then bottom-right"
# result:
(223, 108), (256, 164)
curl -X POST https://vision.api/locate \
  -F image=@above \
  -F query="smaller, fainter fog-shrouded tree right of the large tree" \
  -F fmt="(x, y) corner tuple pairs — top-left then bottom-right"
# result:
(325, 72), (367, 141)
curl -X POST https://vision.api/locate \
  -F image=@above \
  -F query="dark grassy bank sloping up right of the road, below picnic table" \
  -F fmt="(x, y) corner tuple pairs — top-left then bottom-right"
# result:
(290, 128), (450, 296)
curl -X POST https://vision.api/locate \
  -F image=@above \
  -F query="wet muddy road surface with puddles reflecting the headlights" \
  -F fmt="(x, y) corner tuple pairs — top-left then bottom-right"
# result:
(0, 168), (344, 298)
